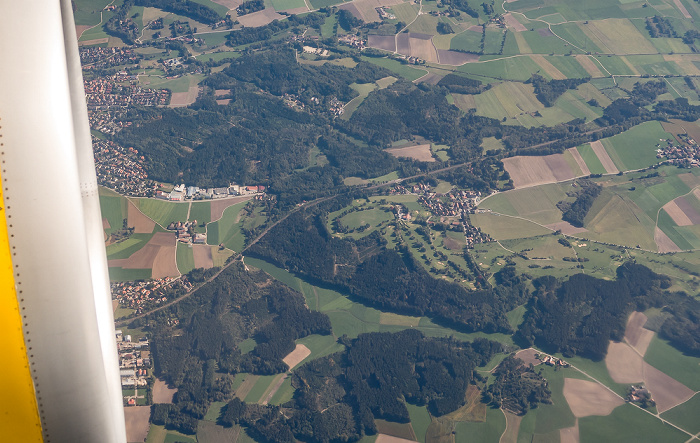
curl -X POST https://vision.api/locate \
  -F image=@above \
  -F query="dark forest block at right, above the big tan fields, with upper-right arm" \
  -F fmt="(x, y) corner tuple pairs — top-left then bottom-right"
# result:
(516, 262), (668, 359)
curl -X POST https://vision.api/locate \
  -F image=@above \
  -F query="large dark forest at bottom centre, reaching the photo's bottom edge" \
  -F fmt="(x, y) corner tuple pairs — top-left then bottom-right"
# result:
(219, 329), (501, 442)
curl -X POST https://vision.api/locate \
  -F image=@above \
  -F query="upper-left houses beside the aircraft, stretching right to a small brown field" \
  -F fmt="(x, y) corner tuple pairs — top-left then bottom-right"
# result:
(84, 71), (170, 111)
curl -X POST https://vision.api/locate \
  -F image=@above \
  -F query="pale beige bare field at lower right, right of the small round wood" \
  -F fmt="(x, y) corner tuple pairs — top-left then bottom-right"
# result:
(564, 378), (625, 418)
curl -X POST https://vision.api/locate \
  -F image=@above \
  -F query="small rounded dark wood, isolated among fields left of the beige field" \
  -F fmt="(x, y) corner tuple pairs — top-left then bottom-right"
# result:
(484, 355), (552, 415)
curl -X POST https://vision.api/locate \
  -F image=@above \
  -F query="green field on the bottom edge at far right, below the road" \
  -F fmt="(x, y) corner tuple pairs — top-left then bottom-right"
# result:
(578, 404), (689, 443)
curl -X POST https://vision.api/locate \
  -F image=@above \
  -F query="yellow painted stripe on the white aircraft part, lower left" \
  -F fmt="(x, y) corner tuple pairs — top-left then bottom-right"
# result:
(0, 169), (43, 442)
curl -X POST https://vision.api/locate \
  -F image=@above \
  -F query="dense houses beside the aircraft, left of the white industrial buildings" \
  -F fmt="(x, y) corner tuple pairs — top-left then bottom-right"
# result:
(92, 137), (157, 197)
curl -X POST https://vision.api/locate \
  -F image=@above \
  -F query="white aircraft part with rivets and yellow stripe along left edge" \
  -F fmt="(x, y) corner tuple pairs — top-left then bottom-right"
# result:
(0, 0), (126, 442)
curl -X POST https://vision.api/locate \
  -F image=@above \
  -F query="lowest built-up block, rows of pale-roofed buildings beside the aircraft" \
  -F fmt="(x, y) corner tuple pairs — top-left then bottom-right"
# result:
(116, 329), (152, 406)
